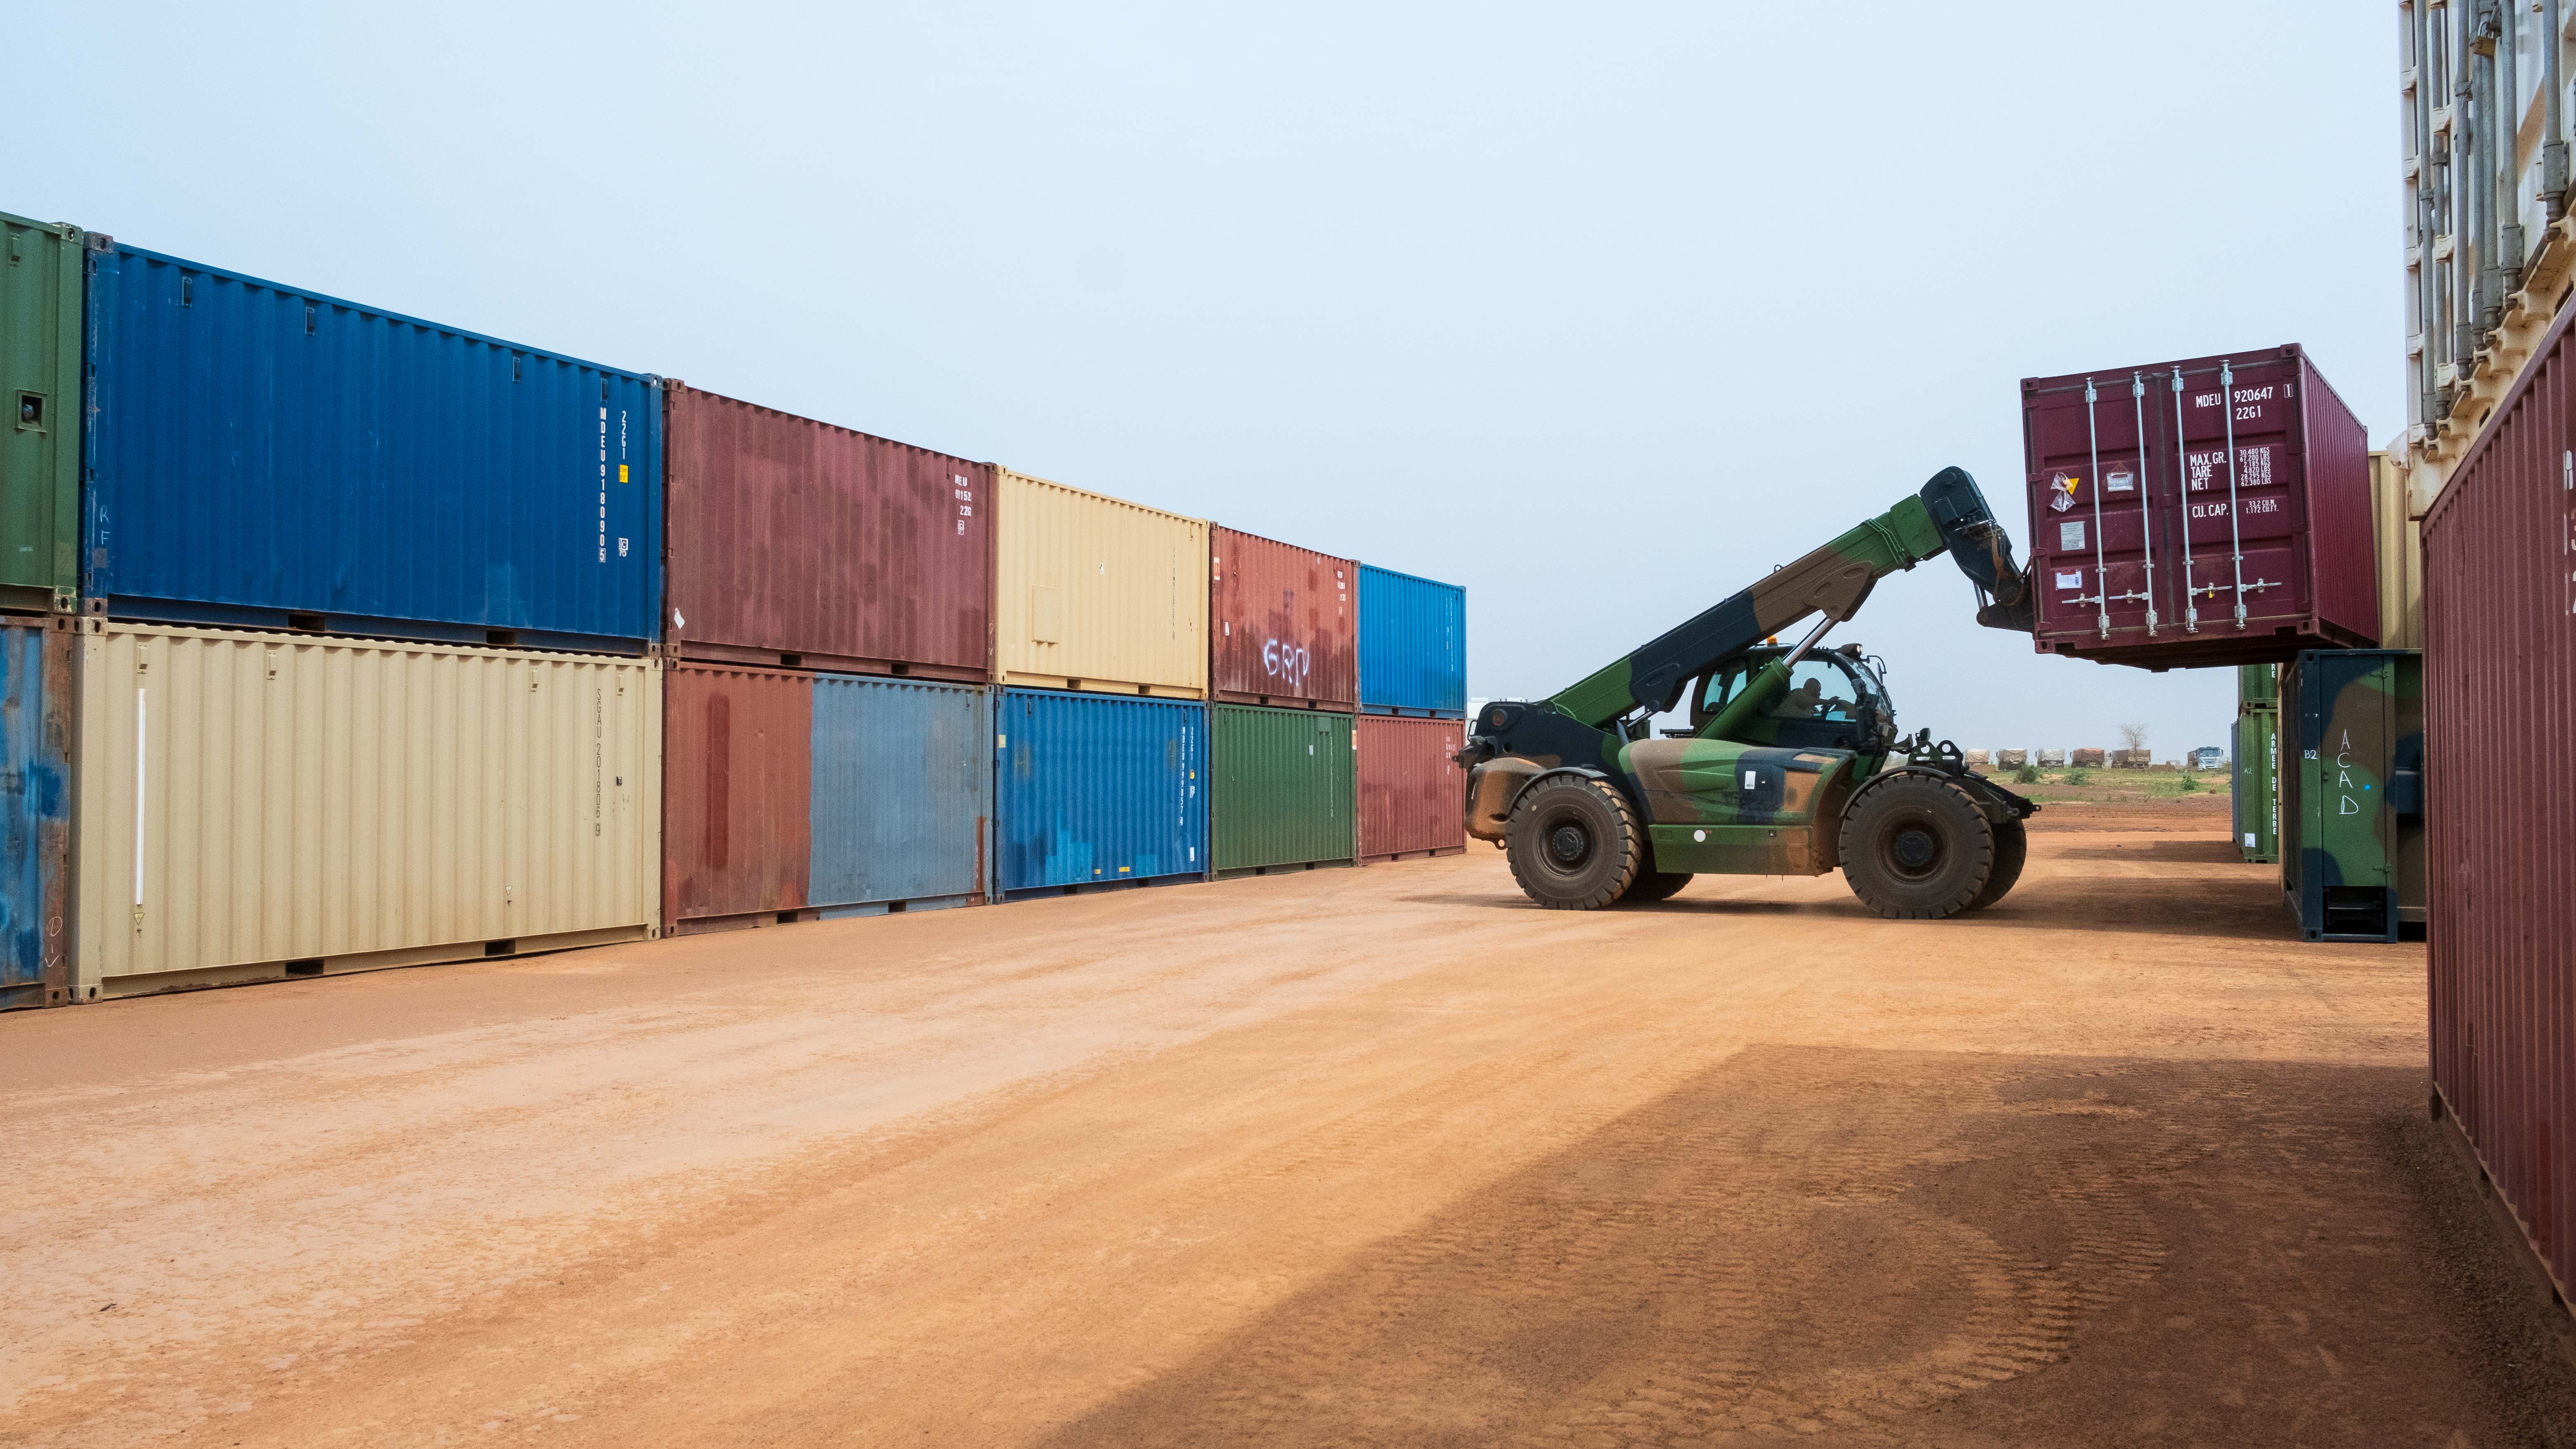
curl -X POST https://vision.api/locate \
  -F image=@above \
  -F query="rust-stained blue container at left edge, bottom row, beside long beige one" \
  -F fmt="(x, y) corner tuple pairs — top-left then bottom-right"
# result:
(0, 619), (77, 1011)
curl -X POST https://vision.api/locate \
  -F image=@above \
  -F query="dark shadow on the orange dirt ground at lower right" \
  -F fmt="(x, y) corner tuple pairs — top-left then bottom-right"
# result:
(1049, 1047), (2576, 1449)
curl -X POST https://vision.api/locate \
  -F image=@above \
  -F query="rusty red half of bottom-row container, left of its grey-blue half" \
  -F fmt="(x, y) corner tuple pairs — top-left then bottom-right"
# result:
(662, 665), (814, 933)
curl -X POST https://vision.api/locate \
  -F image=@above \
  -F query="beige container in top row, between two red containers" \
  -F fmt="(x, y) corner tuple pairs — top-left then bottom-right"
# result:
(992, 466), (1208, 699)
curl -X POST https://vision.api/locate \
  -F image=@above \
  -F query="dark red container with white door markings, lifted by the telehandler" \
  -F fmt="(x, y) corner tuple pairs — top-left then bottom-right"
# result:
(2022, 343), (2380, 670)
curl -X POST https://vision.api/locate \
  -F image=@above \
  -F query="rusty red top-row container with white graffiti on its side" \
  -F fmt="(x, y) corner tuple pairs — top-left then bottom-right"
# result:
(1208, 523), (1360, 709)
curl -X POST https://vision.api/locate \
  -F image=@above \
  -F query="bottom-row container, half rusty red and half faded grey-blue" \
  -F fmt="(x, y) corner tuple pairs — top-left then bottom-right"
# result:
(662, 665), (992, 931)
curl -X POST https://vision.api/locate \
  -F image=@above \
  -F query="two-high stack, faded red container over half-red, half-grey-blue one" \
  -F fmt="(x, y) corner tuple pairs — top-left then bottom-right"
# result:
(662, 381), (994, 931)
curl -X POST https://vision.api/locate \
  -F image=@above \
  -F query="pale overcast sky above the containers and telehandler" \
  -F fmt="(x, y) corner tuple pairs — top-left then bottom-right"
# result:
(0, 0), (2403, 755)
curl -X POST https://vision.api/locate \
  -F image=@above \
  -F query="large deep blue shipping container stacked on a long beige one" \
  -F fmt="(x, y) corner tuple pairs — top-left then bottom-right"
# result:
(83, 237), (662, 652)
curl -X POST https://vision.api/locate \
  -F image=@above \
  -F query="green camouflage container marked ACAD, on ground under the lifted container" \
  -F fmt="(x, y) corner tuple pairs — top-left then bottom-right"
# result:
(2280, 650), (2424, 941)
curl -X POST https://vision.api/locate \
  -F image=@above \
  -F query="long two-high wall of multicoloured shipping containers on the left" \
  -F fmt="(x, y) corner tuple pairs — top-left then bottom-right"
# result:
(0, 206), (1466, 1008)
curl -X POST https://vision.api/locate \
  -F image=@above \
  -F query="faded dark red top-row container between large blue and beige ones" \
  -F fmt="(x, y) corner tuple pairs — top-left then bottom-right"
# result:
(662, 381), (992, 681)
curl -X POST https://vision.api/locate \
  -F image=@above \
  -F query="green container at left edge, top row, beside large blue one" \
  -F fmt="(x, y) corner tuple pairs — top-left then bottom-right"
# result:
(0, 211), (83, 613)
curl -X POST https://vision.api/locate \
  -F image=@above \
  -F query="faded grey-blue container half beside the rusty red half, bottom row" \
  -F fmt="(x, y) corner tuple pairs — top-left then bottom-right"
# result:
(806, 673), (992, 921)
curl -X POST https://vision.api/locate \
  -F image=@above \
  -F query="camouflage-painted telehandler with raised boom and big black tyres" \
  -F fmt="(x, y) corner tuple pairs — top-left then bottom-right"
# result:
(1458, 466), (2038, 921)
